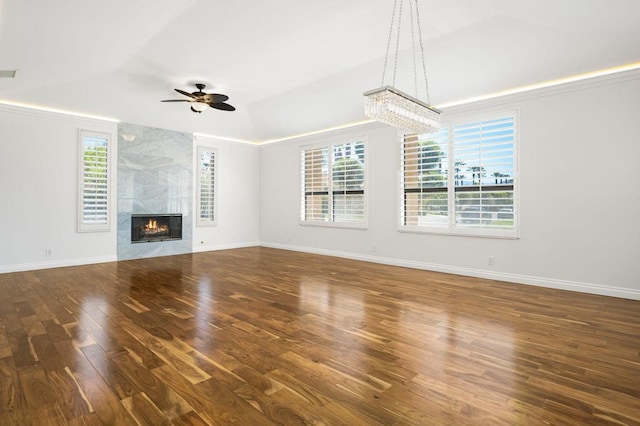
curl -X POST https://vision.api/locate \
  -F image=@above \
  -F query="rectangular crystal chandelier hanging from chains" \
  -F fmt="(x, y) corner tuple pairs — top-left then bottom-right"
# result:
(364, 0), (442, 134)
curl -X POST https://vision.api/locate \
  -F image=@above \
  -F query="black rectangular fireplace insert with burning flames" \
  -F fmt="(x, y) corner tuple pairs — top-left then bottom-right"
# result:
(131, 214), (182, 243)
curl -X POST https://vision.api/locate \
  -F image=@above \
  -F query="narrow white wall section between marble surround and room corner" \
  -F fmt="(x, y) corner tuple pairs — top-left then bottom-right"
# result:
(193, 136), (260, 252)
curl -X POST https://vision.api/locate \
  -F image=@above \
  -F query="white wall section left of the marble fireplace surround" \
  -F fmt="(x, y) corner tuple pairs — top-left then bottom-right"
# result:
(0, 106), (117, 272)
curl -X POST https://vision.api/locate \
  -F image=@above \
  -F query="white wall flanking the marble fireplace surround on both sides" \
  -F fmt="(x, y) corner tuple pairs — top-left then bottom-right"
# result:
(0, 105), (260, 273)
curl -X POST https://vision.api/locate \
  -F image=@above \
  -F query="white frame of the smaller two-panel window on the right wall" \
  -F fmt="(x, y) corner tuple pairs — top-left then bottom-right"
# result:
(298, 135), (369, 229)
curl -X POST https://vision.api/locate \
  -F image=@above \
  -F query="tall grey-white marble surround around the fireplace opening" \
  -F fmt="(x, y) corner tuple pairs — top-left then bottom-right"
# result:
(117, 123), (193, 260)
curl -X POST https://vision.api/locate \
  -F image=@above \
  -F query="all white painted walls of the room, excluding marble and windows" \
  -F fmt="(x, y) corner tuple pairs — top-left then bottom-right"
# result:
(0, 71), (640, 299)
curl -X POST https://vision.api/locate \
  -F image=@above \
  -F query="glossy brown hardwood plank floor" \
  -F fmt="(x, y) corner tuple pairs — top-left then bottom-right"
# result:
(0, 248), (640, 426)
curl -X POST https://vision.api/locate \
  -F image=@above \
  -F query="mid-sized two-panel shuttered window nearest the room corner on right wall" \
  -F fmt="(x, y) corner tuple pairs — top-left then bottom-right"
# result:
(300, 141), (366, 227)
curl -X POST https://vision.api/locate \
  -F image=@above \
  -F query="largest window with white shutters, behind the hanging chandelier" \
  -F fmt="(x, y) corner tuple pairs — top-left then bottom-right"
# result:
(401, 113), (517, 238)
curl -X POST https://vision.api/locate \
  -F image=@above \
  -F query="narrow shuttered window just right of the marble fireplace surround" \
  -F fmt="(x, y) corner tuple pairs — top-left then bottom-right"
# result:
(196, 146), (217, 226)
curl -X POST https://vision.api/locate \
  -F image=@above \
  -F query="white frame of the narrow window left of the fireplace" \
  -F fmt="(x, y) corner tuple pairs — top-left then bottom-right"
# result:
(78, 129), (113, 233)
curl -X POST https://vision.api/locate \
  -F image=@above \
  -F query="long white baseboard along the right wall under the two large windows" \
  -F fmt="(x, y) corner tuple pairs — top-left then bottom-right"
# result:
(260, 241), (640, 300)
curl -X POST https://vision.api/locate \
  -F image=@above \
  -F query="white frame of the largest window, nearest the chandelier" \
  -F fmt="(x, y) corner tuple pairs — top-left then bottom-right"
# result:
(398, 108), (521, 239)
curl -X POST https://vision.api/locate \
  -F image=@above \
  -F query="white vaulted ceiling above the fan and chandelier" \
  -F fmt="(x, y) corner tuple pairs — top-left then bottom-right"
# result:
(0, 0), (640, 142)
